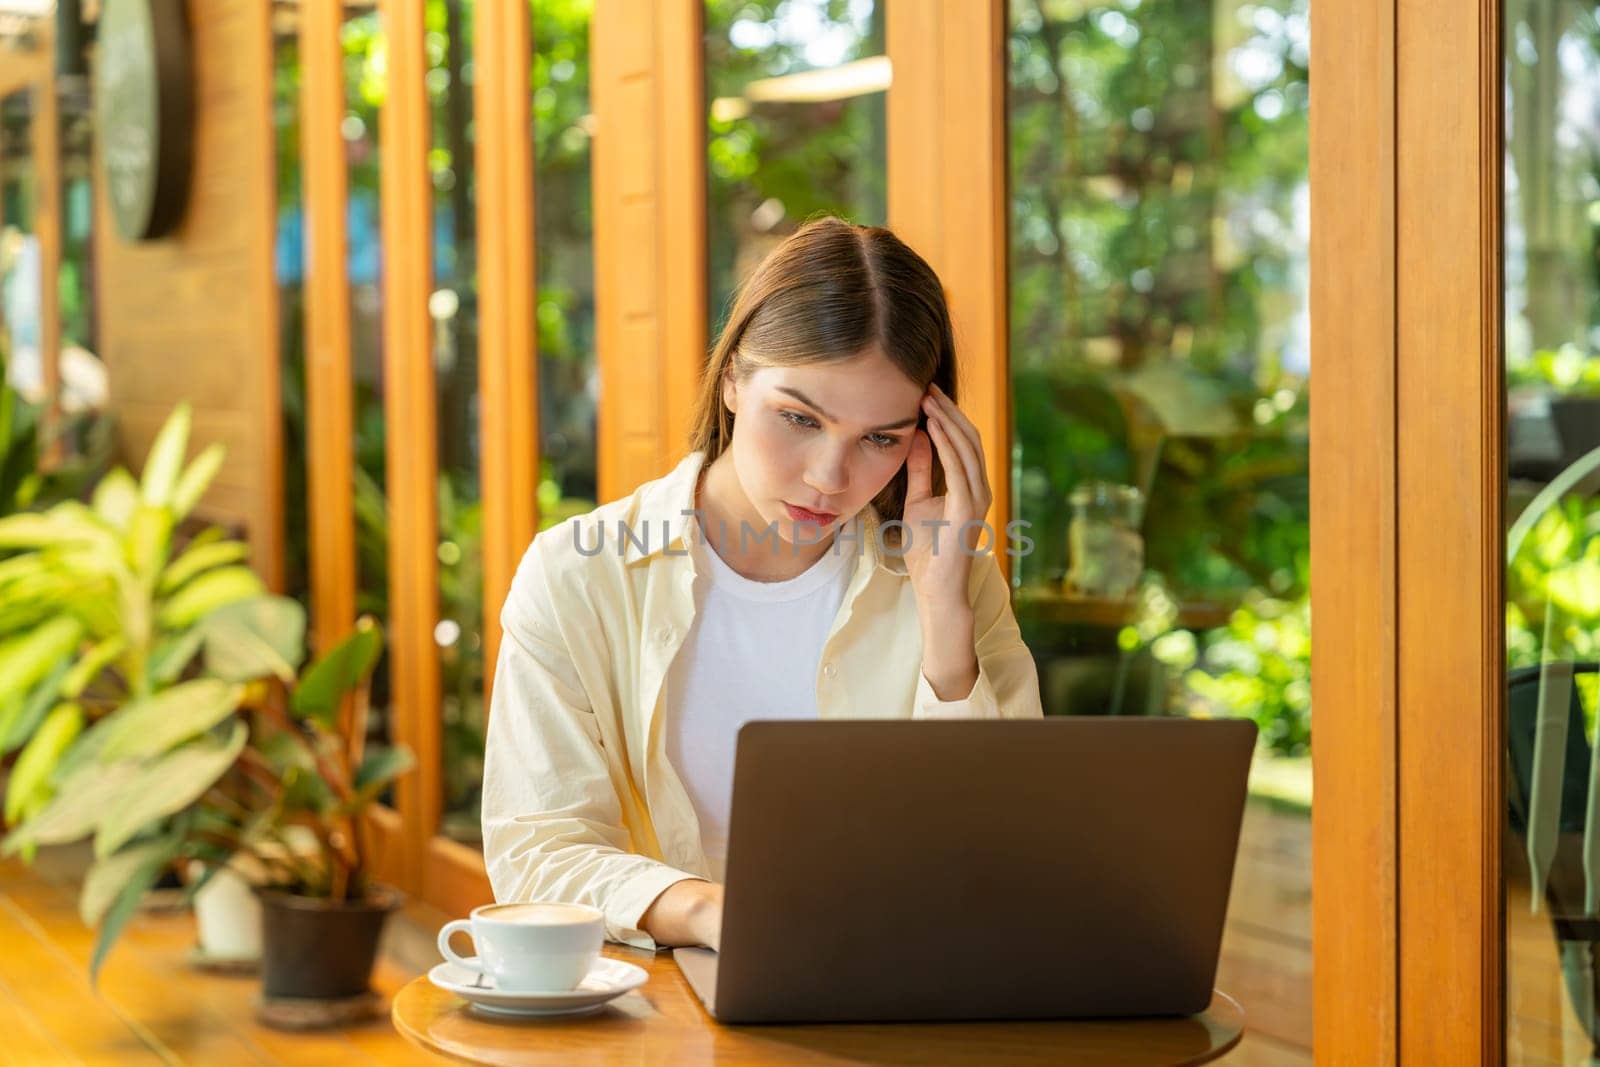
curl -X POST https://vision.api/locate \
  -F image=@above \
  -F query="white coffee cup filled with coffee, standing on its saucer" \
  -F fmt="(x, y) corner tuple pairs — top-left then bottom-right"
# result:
(438, 904), (605, 993)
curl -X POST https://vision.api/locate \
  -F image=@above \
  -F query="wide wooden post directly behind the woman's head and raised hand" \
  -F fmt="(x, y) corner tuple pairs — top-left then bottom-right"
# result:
(886, 0), (1011, 574)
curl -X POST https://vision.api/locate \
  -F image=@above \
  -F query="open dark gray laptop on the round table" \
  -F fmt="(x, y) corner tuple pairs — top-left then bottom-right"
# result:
(674, 718), (1256, 1022)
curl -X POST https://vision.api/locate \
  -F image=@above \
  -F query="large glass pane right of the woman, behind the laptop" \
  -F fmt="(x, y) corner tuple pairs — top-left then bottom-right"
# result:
(1008, 0), (1310, 1056)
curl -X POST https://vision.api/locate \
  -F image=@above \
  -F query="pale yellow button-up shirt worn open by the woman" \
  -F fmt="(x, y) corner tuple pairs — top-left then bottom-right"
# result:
(483, 453), (1042, 949)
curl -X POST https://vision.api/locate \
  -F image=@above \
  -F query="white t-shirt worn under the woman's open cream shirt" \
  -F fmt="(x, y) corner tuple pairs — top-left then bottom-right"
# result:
(664, 521), (859, 881)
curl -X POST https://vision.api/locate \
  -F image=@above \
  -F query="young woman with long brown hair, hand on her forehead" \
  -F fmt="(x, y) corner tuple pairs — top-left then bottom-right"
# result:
(483, 219), (1040, 947)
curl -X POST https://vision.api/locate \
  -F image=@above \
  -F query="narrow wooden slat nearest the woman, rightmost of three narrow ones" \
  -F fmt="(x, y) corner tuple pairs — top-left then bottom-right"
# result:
(474, 3), (539, 715)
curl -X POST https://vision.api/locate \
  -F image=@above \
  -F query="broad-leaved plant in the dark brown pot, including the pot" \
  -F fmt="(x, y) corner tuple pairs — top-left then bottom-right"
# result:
(0, 597), (413, 1000)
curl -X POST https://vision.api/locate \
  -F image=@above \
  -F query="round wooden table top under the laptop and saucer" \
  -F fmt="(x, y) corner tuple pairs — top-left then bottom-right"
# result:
(390, 945), (1245, 1067)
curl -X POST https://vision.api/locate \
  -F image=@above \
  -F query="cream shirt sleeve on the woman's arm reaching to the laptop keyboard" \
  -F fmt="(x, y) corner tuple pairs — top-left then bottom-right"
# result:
(483, 542), (698, 949)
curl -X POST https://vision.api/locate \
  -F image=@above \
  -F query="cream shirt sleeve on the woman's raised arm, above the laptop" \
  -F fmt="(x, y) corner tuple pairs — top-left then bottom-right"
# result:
(912, 552), (1045, 718)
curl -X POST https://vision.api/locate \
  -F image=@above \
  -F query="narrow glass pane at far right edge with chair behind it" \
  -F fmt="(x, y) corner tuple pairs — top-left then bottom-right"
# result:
(1502, 0), (1600, 1064)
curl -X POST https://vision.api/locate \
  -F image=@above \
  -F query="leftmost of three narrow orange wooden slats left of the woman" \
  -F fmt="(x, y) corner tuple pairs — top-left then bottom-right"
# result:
(299, 3), (357, 649)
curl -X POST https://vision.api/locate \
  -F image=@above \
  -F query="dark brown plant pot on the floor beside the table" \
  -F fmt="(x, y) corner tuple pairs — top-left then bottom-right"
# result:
(256, 886), (400, 1000)
